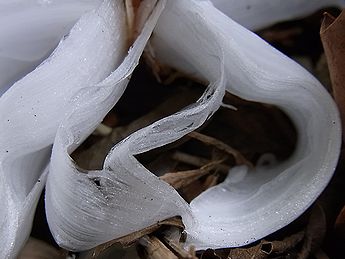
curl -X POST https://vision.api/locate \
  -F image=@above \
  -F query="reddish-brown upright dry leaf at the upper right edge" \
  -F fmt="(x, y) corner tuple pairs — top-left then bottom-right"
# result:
(320, 11), (345, 138)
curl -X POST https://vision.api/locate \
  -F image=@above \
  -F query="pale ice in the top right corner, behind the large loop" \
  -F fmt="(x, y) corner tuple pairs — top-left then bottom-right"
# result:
(207, 0), (345, 30)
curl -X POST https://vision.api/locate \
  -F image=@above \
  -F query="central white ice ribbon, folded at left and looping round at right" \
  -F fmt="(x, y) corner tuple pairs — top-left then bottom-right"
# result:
(46, 0), (340, 254)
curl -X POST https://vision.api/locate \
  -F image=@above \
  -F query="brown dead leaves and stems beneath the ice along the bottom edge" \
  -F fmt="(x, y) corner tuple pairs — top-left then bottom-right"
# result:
(83, 205), (328, 259)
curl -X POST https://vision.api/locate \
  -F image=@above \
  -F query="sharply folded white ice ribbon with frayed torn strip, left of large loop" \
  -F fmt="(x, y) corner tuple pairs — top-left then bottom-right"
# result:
(46, 1), (234, 251)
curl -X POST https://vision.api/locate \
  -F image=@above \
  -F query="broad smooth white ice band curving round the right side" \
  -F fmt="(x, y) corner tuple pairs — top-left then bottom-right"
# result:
(152, 0), (341, 249)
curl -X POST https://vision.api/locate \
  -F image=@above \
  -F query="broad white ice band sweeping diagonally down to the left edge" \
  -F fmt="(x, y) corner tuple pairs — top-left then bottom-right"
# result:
(0, 0), (127, 258)
